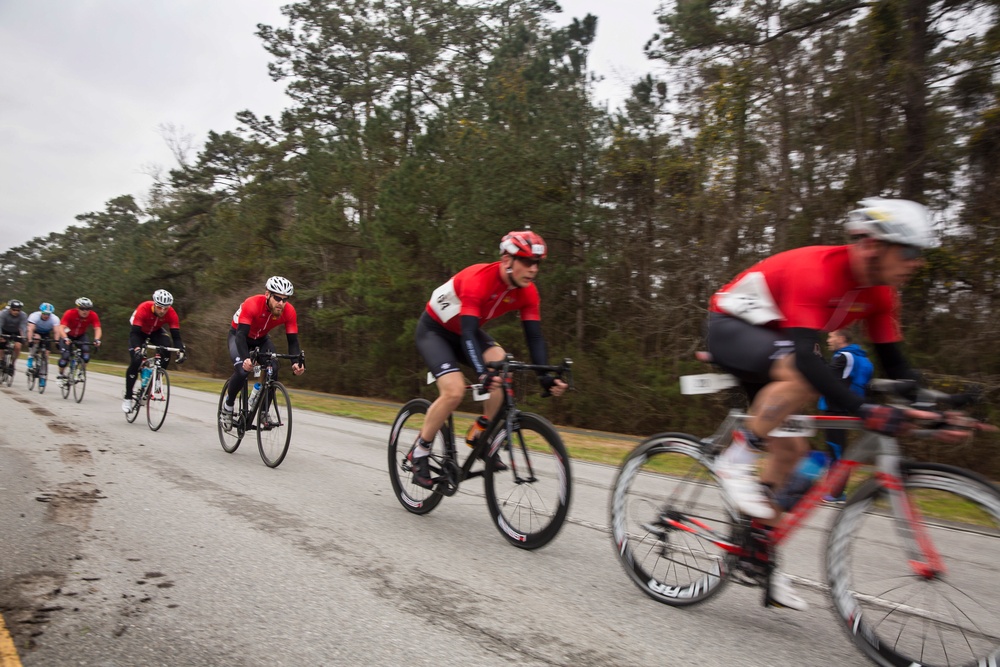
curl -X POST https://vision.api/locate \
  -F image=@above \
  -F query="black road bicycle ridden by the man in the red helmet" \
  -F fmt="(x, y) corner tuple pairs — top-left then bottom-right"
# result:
(389, 355), (572, 549)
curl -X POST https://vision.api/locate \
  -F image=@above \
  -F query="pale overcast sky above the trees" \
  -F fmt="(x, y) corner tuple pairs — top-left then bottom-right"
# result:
(0, 0), (660, 252)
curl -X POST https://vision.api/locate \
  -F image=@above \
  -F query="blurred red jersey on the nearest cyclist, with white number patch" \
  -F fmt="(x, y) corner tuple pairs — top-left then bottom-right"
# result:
(710, 246), (903, 343)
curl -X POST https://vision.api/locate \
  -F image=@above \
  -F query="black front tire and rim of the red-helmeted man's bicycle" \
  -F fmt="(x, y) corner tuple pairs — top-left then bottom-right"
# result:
(483, 412), (573, 550)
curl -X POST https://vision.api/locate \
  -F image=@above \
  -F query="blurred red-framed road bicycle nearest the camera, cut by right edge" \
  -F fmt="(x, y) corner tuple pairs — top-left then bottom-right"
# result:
(611, 374), (1000, 666)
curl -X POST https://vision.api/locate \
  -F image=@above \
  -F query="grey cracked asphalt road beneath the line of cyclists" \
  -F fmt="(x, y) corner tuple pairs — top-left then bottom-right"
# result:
(0, 372), (867, 667)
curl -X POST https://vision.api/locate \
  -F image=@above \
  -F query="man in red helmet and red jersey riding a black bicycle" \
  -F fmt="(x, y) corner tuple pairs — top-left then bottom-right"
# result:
(410, 230), (566, 488)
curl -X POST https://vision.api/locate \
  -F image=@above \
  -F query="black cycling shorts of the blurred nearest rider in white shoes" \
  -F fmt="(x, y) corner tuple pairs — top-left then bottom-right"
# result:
(707, 313), (795, 386)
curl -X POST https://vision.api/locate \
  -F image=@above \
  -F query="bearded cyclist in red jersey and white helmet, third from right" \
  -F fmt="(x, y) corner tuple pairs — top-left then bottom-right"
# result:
(219, 276), (306, 431)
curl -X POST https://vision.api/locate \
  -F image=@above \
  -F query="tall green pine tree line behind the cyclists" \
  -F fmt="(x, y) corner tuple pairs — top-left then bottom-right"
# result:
(0, 0), (1000, 470)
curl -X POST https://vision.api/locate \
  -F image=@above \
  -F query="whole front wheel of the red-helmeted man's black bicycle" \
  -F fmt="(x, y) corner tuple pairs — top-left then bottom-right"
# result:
(483, 412), (573, 549)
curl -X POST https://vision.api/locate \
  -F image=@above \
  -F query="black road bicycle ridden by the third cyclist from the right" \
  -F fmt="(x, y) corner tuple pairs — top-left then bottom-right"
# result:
(216, 350), (305, 468)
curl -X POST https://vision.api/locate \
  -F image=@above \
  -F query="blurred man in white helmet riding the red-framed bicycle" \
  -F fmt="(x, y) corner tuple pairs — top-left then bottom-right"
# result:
(707, 198), (961, 610)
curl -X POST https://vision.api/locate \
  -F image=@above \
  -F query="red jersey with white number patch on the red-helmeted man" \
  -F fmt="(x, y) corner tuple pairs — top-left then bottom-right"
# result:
(427, 262), (542, 334)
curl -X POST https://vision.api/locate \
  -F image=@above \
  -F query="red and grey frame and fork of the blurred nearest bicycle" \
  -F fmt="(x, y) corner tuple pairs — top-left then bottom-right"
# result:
(680, 410), (944, 578)
